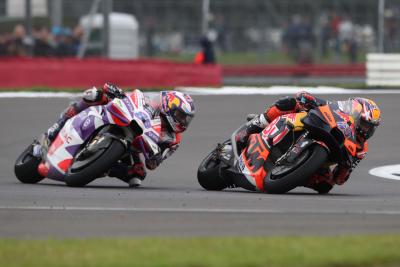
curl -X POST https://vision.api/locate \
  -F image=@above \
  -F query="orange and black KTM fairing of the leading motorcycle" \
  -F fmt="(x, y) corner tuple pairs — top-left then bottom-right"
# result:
(236, 103), (357, 191)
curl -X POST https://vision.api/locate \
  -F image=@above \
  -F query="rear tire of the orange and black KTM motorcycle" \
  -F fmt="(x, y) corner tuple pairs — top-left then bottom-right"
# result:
(197, 150), (228, 191)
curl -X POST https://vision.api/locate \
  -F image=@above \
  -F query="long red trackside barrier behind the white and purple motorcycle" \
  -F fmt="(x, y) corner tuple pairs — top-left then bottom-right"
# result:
(0, 58), (222, 88)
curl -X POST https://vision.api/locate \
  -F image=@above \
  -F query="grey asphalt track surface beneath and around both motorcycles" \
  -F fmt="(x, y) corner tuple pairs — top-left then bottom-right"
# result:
(0, 94), (400, 238)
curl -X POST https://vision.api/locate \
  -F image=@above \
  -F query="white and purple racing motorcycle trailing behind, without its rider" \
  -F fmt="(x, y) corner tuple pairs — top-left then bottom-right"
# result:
(14, 91), (160, 187)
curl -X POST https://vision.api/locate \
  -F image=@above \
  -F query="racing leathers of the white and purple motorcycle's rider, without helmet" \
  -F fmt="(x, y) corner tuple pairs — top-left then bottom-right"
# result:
(40, 83), (181, 187)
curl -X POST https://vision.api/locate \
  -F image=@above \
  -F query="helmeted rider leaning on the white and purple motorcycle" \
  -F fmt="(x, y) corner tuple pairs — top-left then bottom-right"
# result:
(34, 83), (195, 187)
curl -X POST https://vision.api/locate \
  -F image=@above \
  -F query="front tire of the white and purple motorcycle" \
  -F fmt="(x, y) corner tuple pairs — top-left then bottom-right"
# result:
(65, 138), (125, 187)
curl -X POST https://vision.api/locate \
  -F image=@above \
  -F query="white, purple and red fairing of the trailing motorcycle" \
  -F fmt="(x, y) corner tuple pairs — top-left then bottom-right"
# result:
(44, 90), (161, 181)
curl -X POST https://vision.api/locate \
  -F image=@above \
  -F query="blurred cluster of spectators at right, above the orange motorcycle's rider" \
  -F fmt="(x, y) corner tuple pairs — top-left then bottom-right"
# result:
(282, 13), (375, 63)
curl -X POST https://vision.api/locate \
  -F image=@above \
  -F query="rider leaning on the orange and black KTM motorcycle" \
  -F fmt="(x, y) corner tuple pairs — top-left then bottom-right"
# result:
(235, 91), (381, 194)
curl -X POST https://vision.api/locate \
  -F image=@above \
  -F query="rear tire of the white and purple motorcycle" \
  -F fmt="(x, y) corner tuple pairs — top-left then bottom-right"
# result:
(14, 145), (44, 184)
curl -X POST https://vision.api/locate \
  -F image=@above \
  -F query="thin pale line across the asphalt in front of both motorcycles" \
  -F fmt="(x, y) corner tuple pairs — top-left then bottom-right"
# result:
(0, 206), (400, 215)
